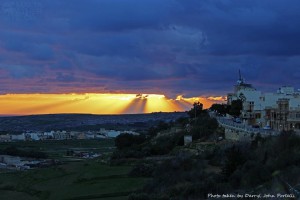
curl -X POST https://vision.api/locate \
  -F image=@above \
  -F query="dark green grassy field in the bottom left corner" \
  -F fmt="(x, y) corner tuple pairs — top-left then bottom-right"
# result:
(0, 160), (146, 200)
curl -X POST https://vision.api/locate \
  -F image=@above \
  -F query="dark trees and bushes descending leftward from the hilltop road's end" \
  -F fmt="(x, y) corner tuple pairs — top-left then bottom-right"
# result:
(112, 105), (218, 162)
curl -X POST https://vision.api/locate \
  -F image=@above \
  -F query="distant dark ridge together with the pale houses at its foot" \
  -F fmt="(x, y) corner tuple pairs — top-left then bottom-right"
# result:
(0, 112), (187, 142)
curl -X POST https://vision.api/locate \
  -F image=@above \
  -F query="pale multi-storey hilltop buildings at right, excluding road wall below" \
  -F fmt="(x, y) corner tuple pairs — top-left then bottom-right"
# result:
(227, 71), (300, 132)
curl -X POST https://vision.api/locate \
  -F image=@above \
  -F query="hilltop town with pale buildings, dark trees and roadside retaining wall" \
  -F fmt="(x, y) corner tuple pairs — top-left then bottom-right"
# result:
(210, 74), (300, 140)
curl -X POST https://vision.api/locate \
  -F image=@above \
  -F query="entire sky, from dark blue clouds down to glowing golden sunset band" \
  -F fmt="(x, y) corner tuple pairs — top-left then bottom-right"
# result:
(0, 0), (300, 115)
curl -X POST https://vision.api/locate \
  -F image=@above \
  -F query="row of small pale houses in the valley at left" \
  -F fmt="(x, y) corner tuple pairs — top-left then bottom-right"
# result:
(0, 128), (139, 142)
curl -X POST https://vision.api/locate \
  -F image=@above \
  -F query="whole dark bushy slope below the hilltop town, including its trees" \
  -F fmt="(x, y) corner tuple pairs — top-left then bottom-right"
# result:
(111, 102), (300, 200)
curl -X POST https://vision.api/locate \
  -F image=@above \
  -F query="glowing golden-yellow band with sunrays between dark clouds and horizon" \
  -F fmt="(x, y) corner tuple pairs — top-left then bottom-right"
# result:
(0, 93), (224, 115)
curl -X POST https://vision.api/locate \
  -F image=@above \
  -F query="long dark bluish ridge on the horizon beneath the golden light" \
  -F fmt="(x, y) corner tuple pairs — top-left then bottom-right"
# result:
(0, 112), (187, 131)
